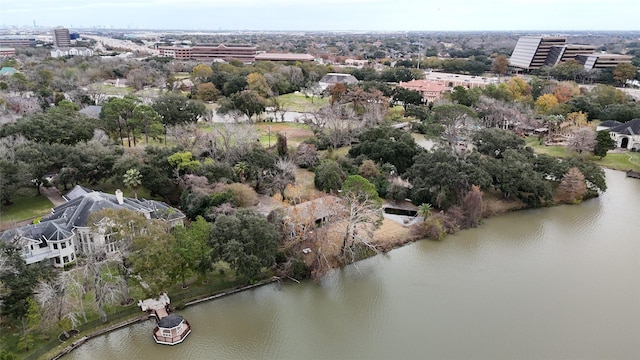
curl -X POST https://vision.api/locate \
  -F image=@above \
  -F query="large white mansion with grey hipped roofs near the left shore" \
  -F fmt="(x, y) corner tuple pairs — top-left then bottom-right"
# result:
(0, 186), (185, 267)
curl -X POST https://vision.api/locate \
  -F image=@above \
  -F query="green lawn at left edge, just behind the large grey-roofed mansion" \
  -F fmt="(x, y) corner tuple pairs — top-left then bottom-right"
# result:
(0, 188), (53, 223)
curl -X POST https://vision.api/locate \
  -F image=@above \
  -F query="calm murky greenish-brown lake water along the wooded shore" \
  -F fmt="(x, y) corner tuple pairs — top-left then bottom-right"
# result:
(65, 171), (640, 360)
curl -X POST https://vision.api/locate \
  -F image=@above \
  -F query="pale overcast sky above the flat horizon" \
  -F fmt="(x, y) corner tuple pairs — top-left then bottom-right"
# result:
(0, 0), (640, 31)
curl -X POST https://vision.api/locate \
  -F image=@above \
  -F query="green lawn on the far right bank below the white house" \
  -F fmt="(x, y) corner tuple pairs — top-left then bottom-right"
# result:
(526, 136), (640, 171)
